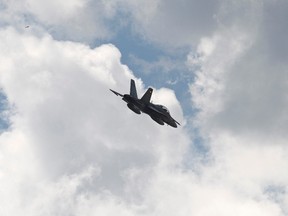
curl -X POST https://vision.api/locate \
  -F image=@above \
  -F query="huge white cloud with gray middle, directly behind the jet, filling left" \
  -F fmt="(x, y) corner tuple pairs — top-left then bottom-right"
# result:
(0, 28), (189, 215)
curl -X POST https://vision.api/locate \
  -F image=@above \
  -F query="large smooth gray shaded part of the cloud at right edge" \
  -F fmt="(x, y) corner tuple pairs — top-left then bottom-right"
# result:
(190, 1), (288, 136)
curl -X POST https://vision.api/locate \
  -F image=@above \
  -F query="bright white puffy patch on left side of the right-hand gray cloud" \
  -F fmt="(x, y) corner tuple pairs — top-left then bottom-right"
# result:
(187, 30), (249, 127)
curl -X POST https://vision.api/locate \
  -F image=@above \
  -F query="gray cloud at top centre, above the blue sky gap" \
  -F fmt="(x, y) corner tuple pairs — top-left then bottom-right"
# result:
(121, 0), (219, 47)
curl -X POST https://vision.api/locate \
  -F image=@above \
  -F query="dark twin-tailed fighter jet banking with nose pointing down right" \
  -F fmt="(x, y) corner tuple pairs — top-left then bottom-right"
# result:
(110, 79), (180, 128)
